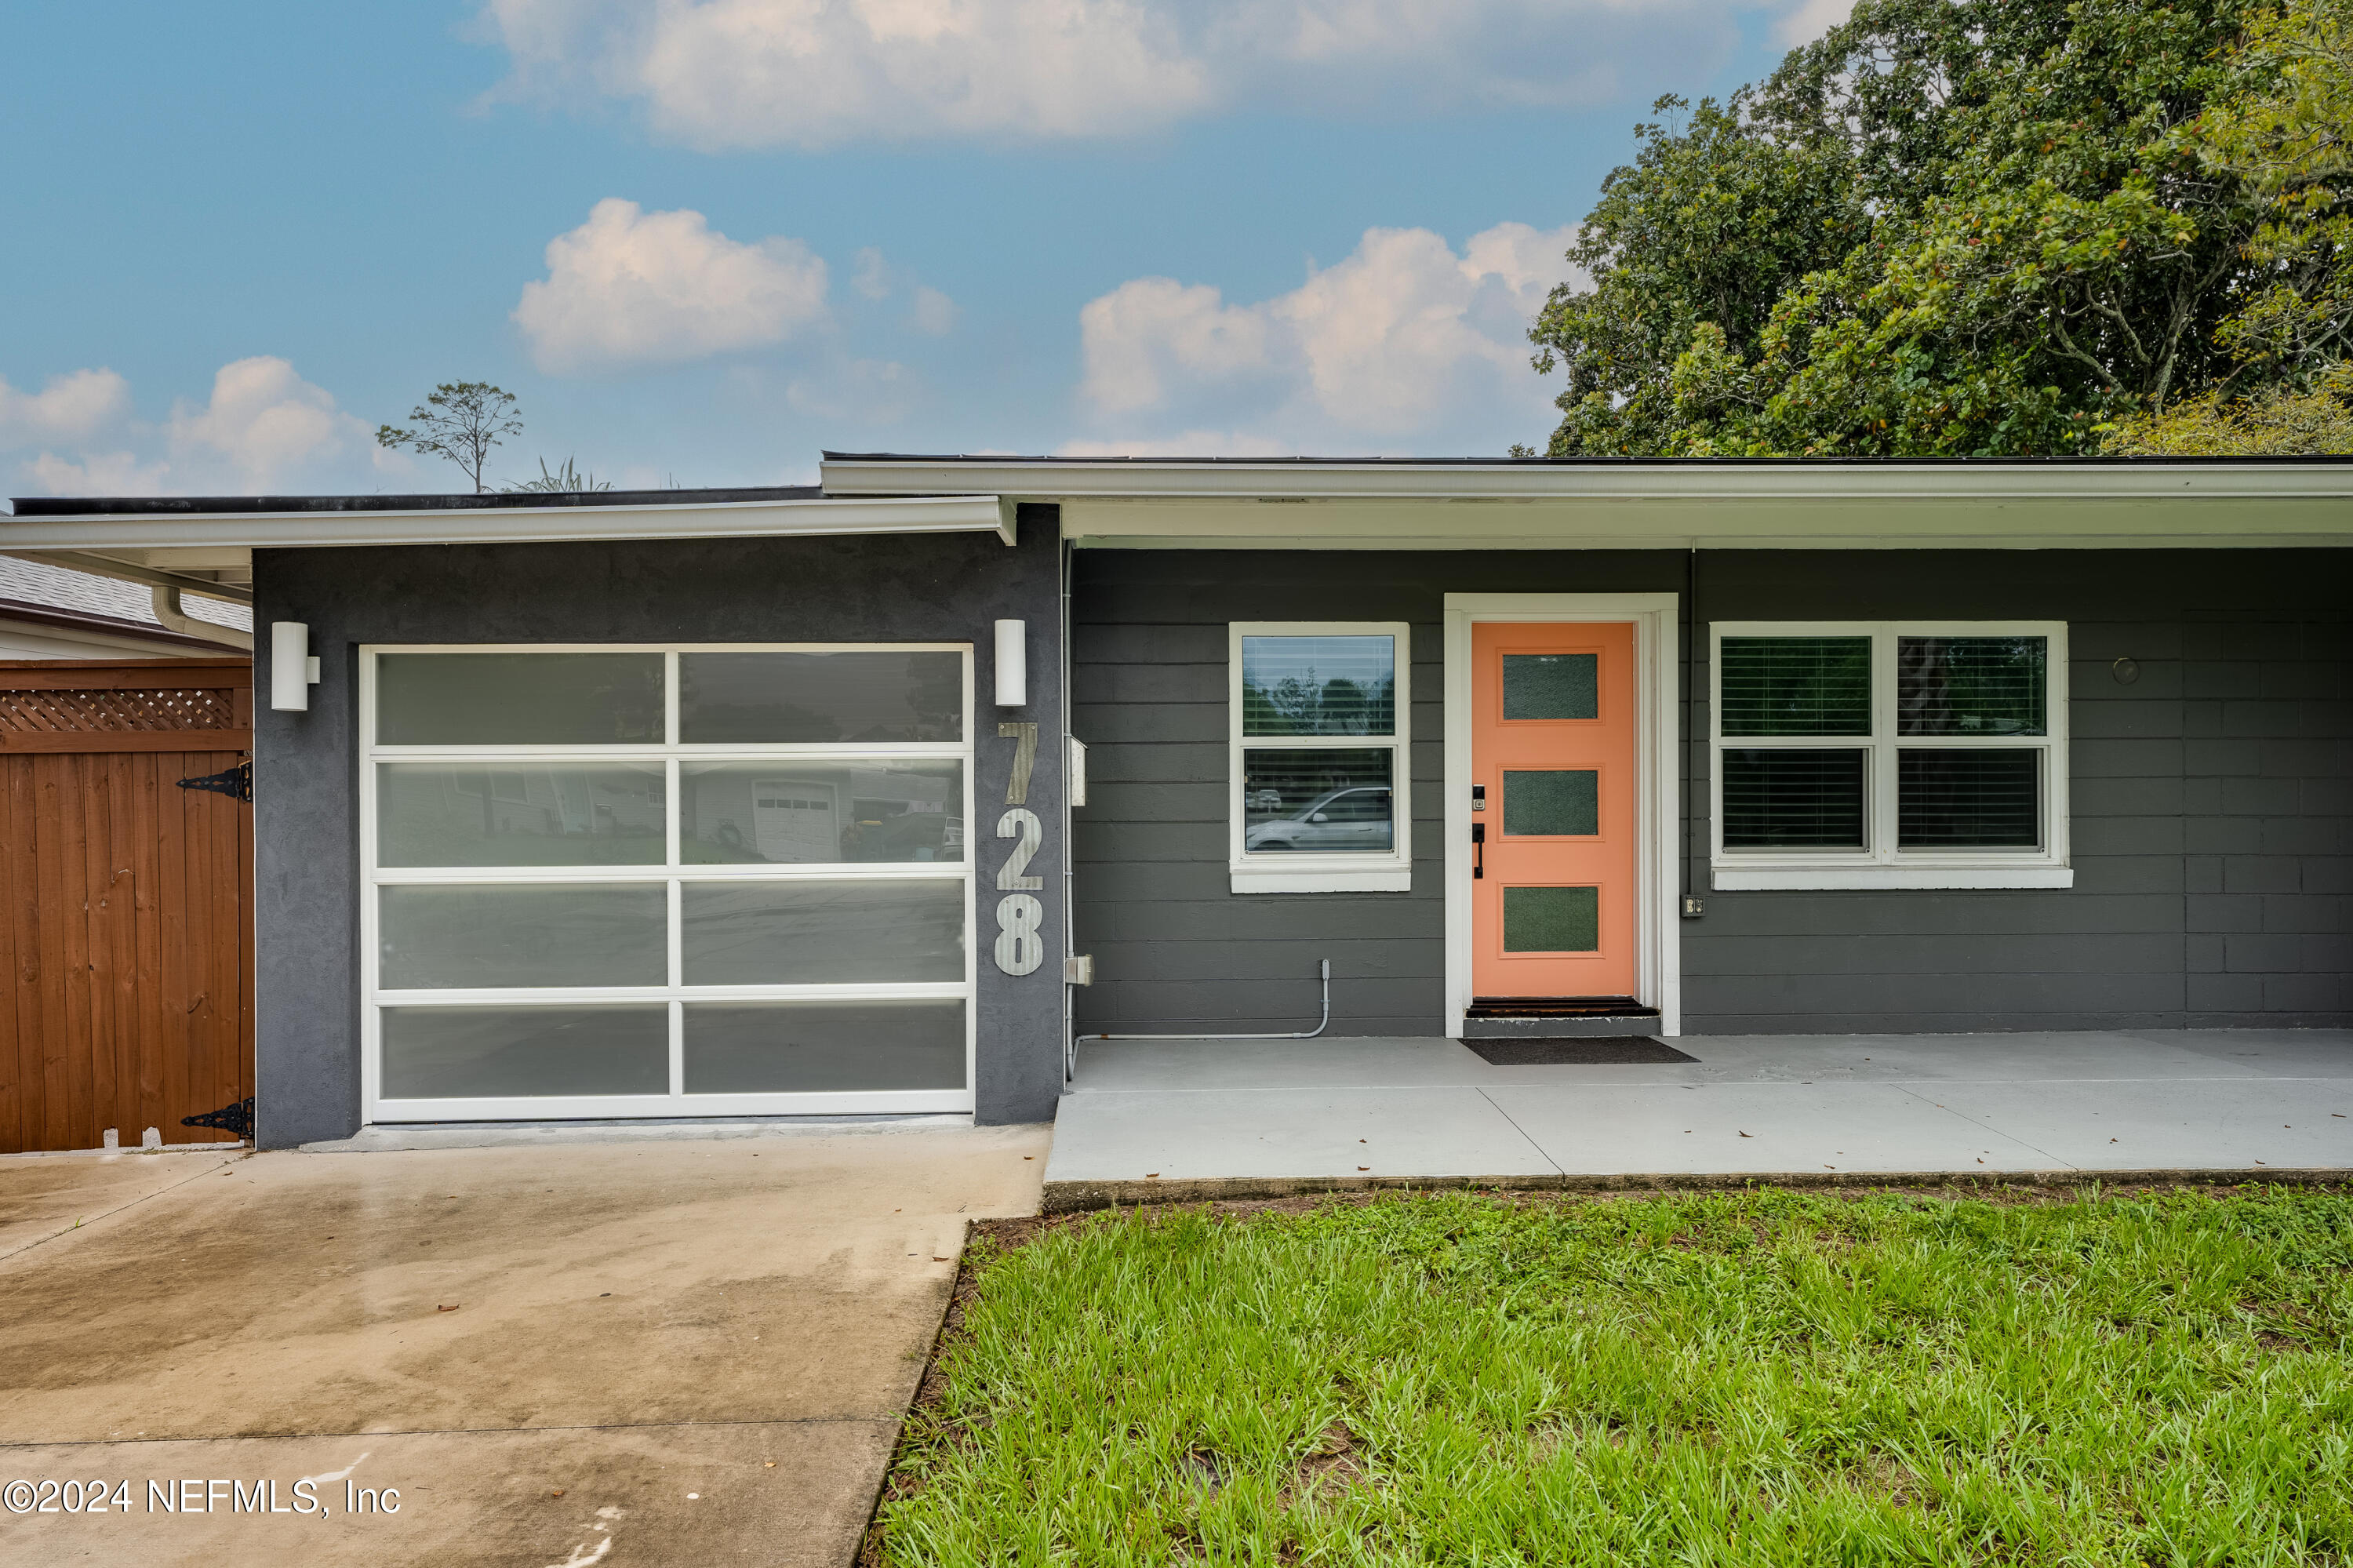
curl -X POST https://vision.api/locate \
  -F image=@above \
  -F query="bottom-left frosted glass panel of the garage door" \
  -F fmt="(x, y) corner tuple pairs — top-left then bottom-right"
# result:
(384, 1006), (671, 1100)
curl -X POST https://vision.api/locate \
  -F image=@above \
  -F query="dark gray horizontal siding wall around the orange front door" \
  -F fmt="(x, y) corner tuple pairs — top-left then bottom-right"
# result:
(1071, 551), (2353, 1034)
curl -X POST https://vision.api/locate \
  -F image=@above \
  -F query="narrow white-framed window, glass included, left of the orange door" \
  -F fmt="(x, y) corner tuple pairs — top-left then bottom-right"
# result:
(1226, 621), (1414, 893)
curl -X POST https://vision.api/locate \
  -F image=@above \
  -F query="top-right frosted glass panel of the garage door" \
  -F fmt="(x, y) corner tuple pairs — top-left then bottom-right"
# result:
(678, 649), (965, 746)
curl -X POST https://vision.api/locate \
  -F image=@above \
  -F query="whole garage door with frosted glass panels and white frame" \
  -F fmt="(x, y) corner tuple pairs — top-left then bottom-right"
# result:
(360, 645), (974, 1121)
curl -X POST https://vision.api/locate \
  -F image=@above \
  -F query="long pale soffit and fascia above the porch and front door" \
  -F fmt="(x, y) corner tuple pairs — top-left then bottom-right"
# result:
(824, 452), (2353, 548)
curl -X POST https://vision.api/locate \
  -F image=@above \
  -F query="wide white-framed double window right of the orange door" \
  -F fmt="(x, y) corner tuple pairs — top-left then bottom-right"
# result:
(1713, 621), (2073, 890)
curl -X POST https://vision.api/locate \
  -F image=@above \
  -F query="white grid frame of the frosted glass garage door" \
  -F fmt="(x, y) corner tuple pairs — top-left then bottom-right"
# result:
(360, 642), (979, 1123)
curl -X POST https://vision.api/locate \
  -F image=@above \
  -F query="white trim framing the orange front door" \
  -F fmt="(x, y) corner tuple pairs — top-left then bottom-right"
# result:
(1445, 593), (1682, 1039)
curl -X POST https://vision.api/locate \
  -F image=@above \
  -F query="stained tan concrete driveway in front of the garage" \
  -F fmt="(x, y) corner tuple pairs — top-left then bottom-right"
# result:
(0, 1128), (1049, 1568)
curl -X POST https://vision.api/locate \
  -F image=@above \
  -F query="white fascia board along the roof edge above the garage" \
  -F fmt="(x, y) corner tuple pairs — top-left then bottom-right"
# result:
(0, 494), (1014, 553)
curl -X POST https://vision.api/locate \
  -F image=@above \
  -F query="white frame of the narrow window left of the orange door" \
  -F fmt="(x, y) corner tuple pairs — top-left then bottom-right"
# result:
(1226, 621), (1414, 893)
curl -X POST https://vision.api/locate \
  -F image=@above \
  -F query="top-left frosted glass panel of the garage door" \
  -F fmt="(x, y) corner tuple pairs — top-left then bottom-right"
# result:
(376, 652), (661, 746)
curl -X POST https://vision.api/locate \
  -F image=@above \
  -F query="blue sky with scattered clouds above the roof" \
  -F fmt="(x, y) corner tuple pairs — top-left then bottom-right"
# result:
(0, 0), (1842, 494)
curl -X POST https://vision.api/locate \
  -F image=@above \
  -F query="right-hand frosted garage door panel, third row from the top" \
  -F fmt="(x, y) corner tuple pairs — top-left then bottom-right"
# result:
(680, 881), (965, 987)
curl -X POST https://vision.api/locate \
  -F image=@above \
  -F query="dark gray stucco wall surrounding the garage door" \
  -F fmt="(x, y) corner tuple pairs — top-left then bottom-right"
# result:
(254, 506), (1064, 1147)
